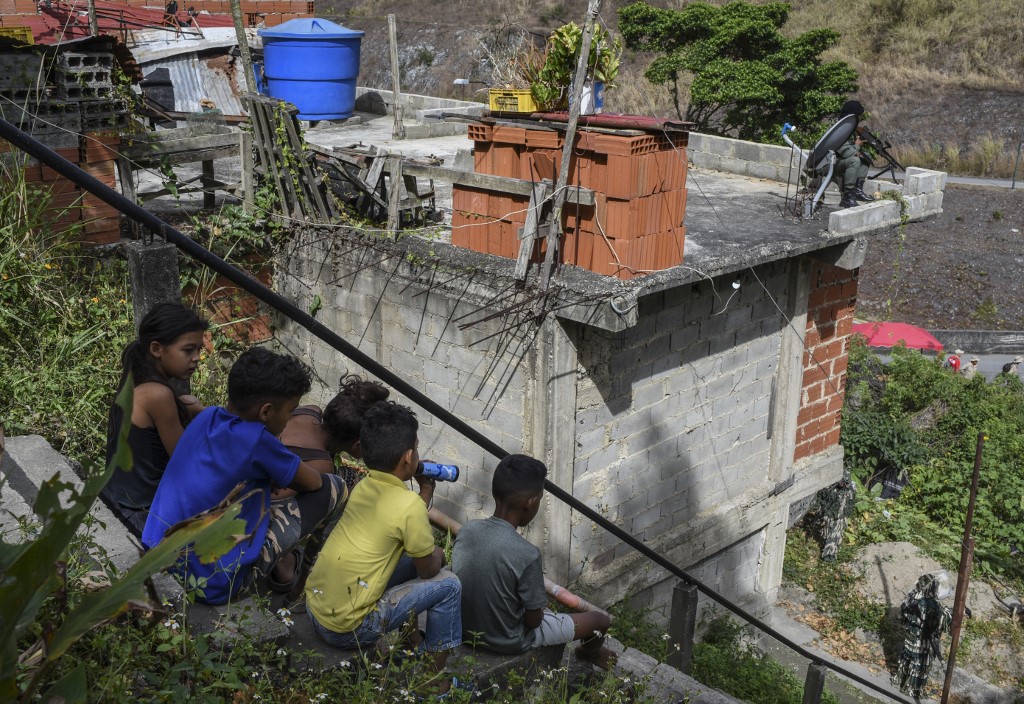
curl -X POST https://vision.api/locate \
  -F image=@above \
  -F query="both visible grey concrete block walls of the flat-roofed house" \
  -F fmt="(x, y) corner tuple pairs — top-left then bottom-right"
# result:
(275, 233), (843, 605)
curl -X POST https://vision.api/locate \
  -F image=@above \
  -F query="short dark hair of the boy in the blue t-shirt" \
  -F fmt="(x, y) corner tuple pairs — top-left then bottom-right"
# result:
(227, 347), (312, 413)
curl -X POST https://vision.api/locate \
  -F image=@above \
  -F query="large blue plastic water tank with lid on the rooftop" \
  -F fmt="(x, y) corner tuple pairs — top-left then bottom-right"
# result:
(259, 17), (364, 120)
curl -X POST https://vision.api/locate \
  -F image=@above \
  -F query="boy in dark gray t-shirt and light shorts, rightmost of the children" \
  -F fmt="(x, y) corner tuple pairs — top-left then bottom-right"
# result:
(452, 454), (613, 669)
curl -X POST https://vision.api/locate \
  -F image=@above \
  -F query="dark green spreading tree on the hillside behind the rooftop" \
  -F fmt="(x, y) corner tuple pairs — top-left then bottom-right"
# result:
(618, 2), (857, 142)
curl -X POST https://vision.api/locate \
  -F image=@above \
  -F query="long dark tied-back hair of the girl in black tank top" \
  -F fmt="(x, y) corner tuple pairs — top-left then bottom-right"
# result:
(118, 303), (210, 426)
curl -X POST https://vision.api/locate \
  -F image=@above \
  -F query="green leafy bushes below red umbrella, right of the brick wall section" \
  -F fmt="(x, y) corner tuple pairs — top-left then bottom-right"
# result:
(842, 343), (1024, 579)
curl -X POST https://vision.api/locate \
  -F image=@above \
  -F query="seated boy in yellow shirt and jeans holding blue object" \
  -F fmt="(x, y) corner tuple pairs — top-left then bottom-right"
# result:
(306, 401), (462, 694)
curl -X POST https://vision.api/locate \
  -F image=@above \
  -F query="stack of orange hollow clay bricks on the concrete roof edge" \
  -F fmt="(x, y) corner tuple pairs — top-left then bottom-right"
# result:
(452, 124), (686, 279)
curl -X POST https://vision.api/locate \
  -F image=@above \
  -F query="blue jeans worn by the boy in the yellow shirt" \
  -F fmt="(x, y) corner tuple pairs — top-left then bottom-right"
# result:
(309, 557), (462, 652)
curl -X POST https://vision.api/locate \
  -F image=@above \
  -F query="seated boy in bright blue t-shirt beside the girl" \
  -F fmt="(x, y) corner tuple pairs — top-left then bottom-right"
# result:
(142, 347), (348, 604)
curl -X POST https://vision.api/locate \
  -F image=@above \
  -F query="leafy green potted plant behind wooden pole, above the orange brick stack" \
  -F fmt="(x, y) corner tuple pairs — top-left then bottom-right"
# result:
(529, 23), (623, 111)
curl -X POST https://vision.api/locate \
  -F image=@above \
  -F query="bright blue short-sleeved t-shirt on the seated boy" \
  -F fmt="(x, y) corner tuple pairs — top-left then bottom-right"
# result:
(142, 406), (299, 604)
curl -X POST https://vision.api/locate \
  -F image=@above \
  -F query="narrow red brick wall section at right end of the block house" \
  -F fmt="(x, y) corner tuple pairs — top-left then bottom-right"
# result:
(794, 261), (858, 460)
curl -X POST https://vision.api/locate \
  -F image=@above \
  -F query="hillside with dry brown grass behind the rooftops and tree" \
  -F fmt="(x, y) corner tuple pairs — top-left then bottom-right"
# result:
(318, 0), (1024, 176)
